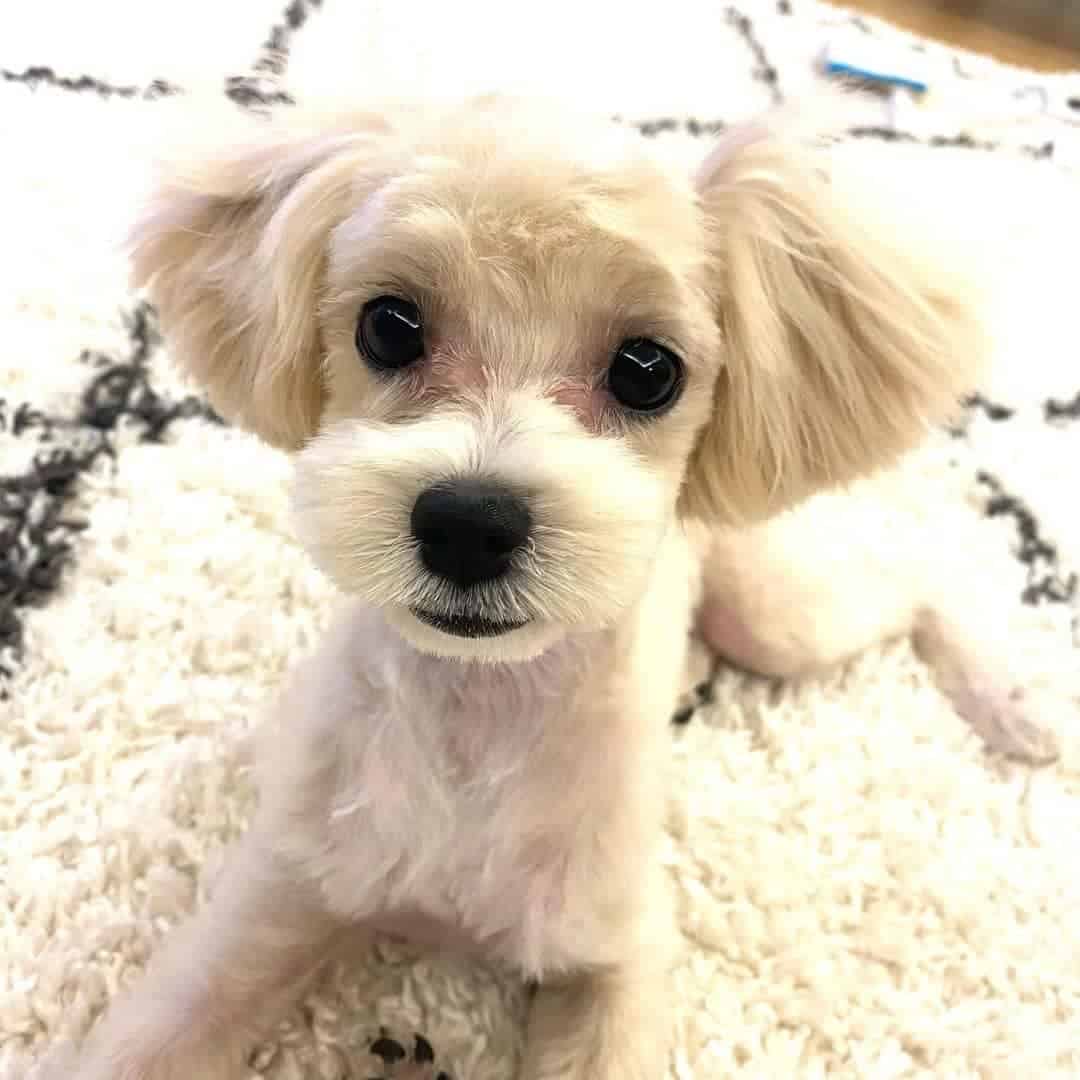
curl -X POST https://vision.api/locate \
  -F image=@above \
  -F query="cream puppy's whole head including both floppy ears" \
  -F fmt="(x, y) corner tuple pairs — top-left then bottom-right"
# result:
(134, 99), (975, 659)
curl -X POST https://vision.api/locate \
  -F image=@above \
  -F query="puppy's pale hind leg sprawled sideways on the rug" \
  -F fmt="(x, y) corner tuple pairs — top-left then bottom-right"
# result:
(698, 501), (1057, 762)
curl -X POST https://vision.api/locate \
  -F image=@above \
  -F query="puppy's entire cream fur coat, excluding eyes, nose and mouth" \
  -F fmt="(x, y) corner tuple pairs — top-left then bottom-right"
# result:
(48, 98), (1047, 1080)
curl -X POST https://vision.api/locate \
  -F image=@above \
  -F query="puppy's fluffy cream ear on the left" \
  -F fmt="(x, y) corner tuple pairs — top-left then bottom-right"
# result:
(130, 103), (387, 449)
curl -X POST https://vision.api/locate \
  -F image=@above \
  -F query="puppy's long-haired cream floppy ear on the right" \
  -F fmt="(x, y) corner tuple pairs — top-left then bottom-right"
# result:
(685, 120), (984, 523)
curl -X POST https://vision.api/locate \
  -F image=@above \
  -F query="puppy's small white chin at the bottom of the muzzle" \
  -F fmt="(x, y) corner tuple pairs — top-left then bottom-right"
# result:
(386, 606), (565, 663)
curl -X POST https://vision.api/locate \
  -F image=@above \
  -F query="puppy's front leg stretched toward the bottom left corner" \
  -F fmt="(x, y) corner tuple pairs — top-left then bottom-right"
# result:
(66, 820), (341, 1080)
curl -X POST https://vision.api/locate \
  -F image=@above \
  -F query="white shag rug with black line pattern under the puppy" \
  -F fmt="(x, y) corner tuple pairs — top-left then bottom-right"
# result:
(0, 0), (1080, 1080)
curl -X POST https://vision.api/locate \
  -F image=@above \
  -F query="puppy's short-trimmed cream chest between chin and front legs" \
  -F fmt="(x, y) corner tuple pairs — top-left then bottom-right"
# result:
(308, 630), (611, 973)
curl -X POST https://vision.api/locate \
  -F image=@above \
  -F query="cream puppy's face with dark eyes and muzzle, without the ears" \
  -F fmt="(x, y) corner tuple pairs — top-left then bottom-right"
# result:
(296, 113), (718, 658)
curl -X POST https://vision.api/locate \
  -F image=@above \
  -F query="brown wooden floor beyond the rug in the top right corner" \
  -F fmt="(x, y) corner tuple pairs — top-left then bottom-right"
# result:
(829, 0), (1080, 71)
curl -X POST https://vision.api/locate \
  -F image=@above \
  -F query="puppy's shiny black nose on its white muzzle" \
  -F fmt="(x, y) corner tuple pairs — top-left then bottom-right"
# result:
(411, 481), (532, 589)
